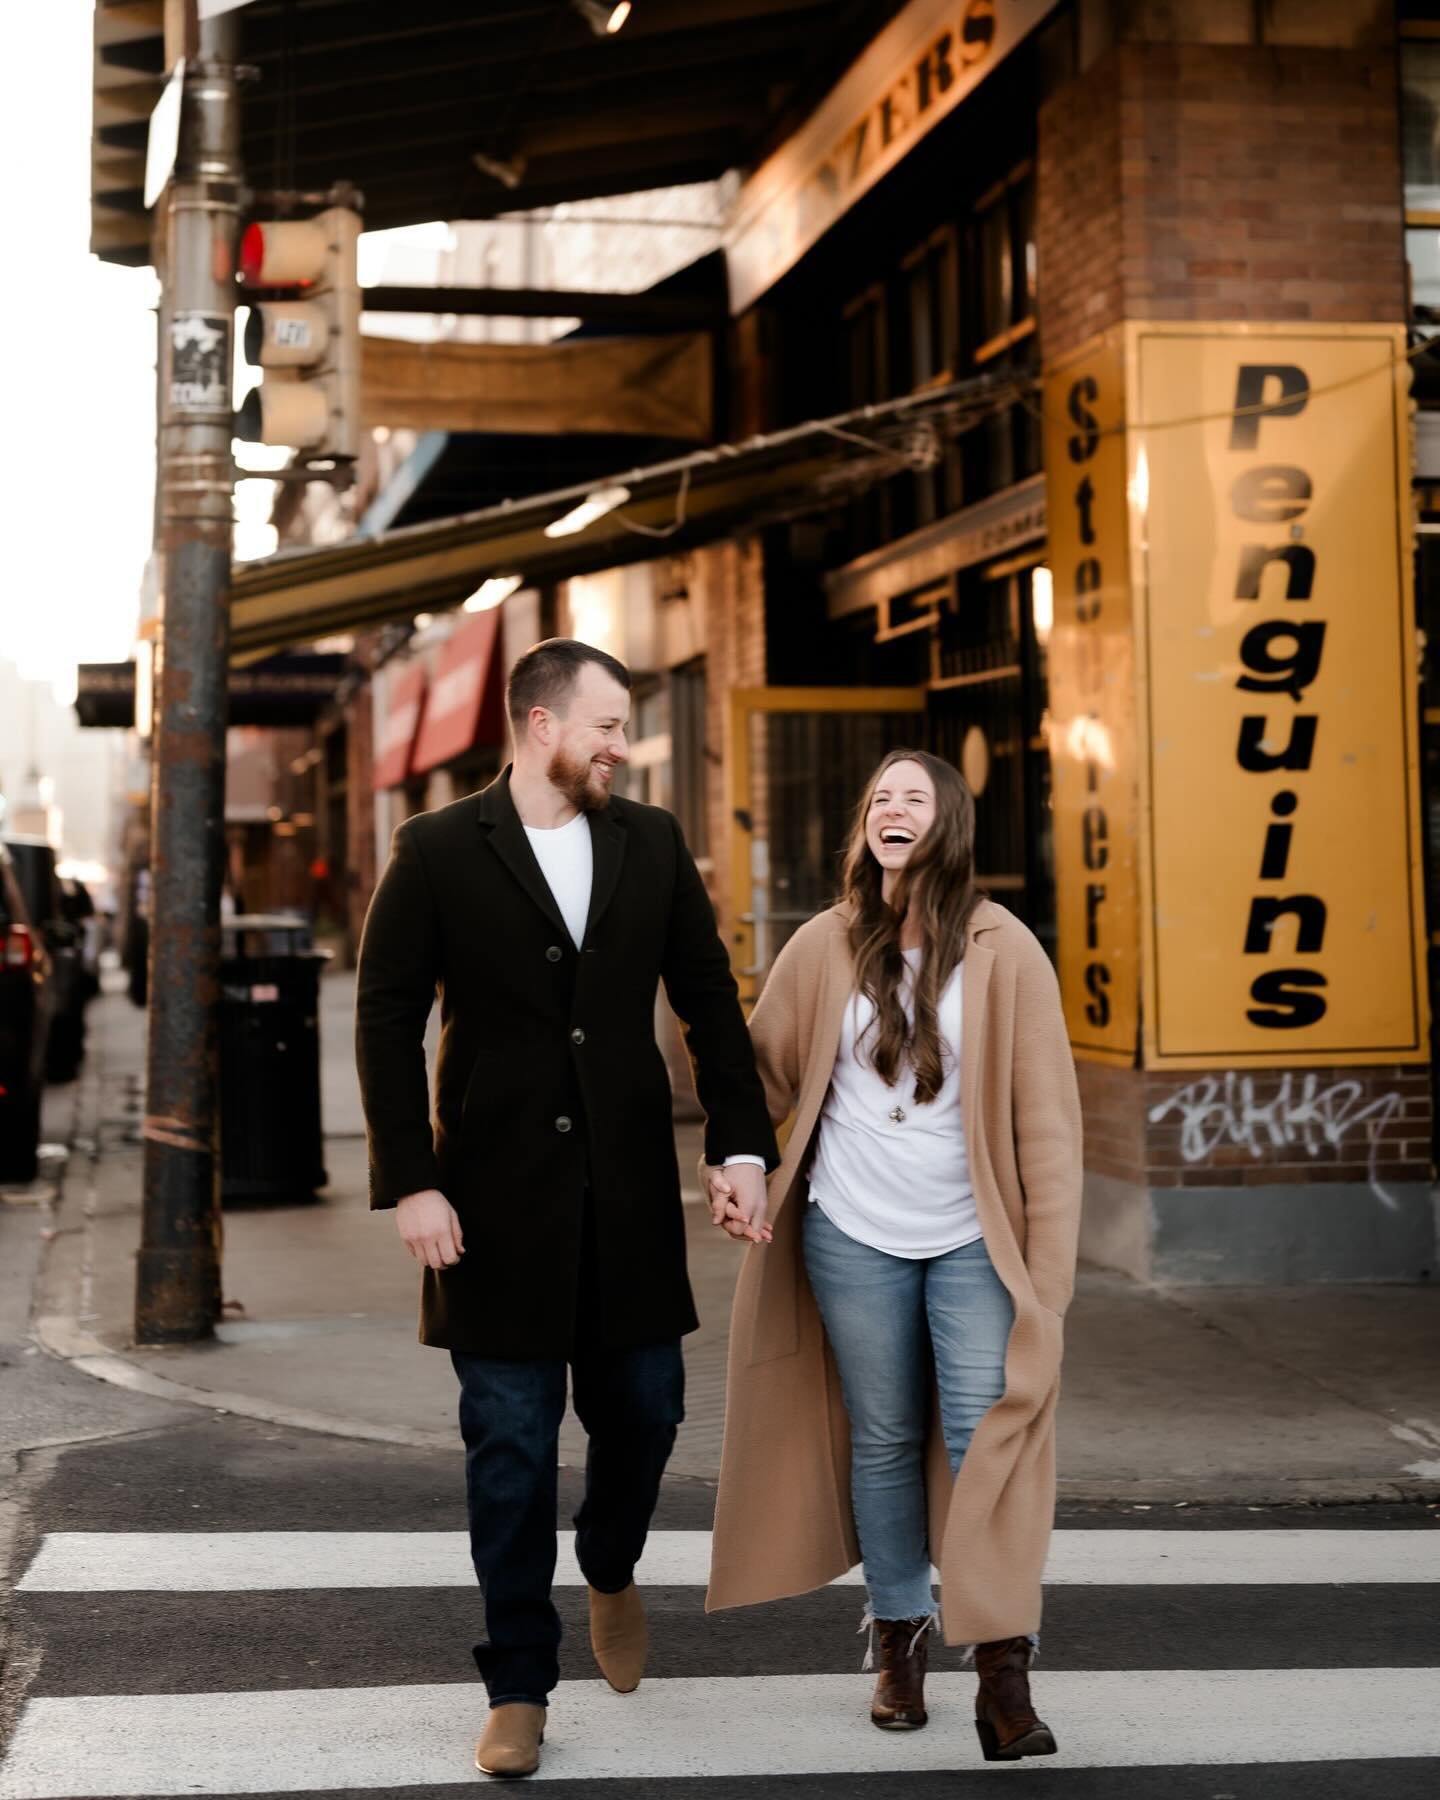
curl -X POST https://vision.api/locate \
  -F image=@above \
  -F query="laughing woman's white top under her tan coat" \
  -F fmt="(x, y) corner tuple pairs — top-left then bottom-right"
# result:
(810, 950), (981, 1258)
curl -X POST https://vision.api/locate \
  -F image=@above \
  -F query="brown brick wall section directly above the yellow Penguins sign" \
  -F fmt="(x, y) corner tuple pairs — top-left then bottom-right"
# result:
(1037, 43), (1404, 362)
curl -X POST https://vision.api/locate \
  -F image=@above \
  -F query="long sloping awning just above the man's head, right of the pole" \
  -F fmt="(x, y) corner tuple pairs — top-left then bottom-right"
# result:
(230, 374), (1024, 661)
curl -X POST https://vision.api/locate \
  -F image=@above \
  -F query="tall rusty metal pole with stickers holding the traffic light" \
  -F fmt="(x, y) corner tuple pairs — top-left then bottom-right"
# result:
(135, 11), (239, 1345)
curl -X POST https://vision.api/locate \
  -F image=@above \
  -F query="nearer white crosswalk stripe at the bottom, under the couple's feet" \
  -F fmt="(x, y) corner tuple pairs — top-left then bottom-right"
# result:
(0, 1669), (1440, 1800)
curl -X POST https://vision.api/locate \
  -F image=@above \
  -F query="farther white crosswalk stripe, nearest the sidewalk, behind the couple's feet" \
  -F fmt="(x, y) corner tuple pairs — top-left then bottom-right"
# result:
(18, 1528), (1440, 1593)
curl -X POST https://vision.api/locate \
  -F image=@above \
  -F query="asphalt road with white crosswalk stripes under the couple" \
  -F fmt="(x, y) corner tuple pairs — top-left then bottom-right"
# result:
(0, 1413), (1440, 1800)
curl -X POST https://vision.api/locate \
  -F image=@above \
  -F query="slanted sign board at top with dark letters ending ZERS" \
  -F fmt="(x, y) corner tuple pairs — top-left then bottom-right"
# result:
(725, 0), (1055, 313)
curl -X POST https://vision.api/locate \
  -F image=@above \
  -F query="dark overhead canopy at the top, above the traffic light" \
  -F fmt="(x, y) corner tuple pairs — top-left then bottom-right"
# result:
(90, 0), (898, 263)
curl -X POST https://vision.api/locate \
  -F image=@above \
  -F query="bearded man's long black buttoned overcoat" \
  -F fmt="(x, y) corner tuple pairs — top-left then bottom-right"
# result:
(356, 770), (778, 1357)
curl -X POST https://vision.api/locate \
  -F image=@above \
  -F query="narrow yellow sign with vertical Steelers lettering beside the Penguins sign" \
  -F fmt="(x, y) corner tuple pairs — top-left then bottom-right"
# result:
(1044, 335), (1139, 1064)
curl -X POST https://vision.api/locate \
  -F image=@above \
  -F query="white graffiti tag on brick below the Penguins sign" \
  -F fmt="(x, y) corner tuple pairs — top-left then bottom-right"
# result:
(1150, 1069), (1404, 1208)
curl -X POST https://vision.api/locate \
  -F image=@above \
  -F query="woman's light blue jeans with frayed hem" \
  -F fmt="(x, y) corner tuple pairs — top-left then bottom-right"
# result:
(805, 1204), (1015, 1618)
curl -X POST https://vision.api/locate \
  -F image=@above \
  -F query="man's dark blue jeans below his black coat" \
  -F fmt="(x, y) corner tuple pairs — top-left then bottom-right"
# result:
(450, 1343), (684, 1706)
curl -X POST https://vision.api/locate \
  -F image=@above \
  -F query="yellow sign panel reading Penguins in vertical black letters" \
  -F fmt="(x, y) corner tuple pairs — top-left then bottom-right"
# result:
(1137, 324), (1427, 1067)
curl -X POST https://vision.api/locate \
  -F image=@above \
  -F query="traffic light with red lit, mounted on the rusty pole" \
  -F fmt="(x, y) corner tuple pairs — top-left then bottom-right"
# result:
(236, 207), (360, 459)
